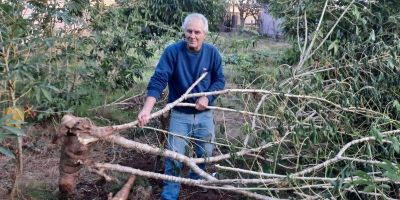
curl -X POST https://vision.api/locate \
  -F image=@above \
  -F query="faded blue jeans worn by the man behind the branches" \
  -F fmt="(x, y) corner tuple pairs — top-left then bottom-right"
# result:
(161, 110), (215, 200)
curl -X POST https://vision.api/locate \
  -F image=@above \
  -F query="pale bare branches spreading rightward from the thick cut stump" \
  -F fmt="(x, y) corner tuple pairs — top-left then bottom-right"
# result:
(60, 73), (400, 199)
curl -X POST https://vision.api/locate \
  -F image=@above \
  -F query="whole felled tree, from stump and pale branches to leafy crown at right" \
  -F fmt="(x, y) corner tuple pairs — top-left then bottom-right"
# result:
(57, 0), (400, 199)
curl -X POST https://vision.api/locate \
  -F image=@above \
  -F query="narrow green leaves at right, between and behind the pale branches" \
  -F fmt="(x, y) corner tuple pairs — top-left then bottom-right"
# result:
(247, 0), (400, 198)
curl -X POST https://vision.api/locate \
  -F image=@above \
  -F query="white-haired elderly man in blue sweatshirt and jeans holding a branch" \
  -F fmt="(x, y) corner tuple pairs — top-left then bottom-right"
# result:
(138, 13), (225, 199)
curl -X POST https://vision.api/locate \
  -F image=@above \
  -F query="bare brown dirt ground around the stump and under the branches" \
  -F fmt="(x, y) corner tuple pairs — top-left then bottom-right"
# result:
(0, 119), (242, 200)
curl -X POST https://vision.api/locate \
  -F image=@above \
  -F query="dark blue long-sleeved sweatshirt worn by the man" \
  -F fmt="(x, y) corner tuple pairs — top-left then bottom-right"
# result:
(147, 41), (225, 114)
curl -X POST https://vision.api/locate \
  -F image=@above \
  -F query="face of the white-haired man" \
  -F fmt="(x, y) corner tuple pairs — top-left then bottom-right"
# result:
(185, 19), (206, 51)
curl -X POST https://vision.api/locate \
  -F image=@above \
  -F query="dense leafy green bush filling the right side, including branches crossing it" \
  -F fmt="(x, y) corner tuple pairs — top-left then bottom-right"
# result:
(214, 0), (400, 199)
